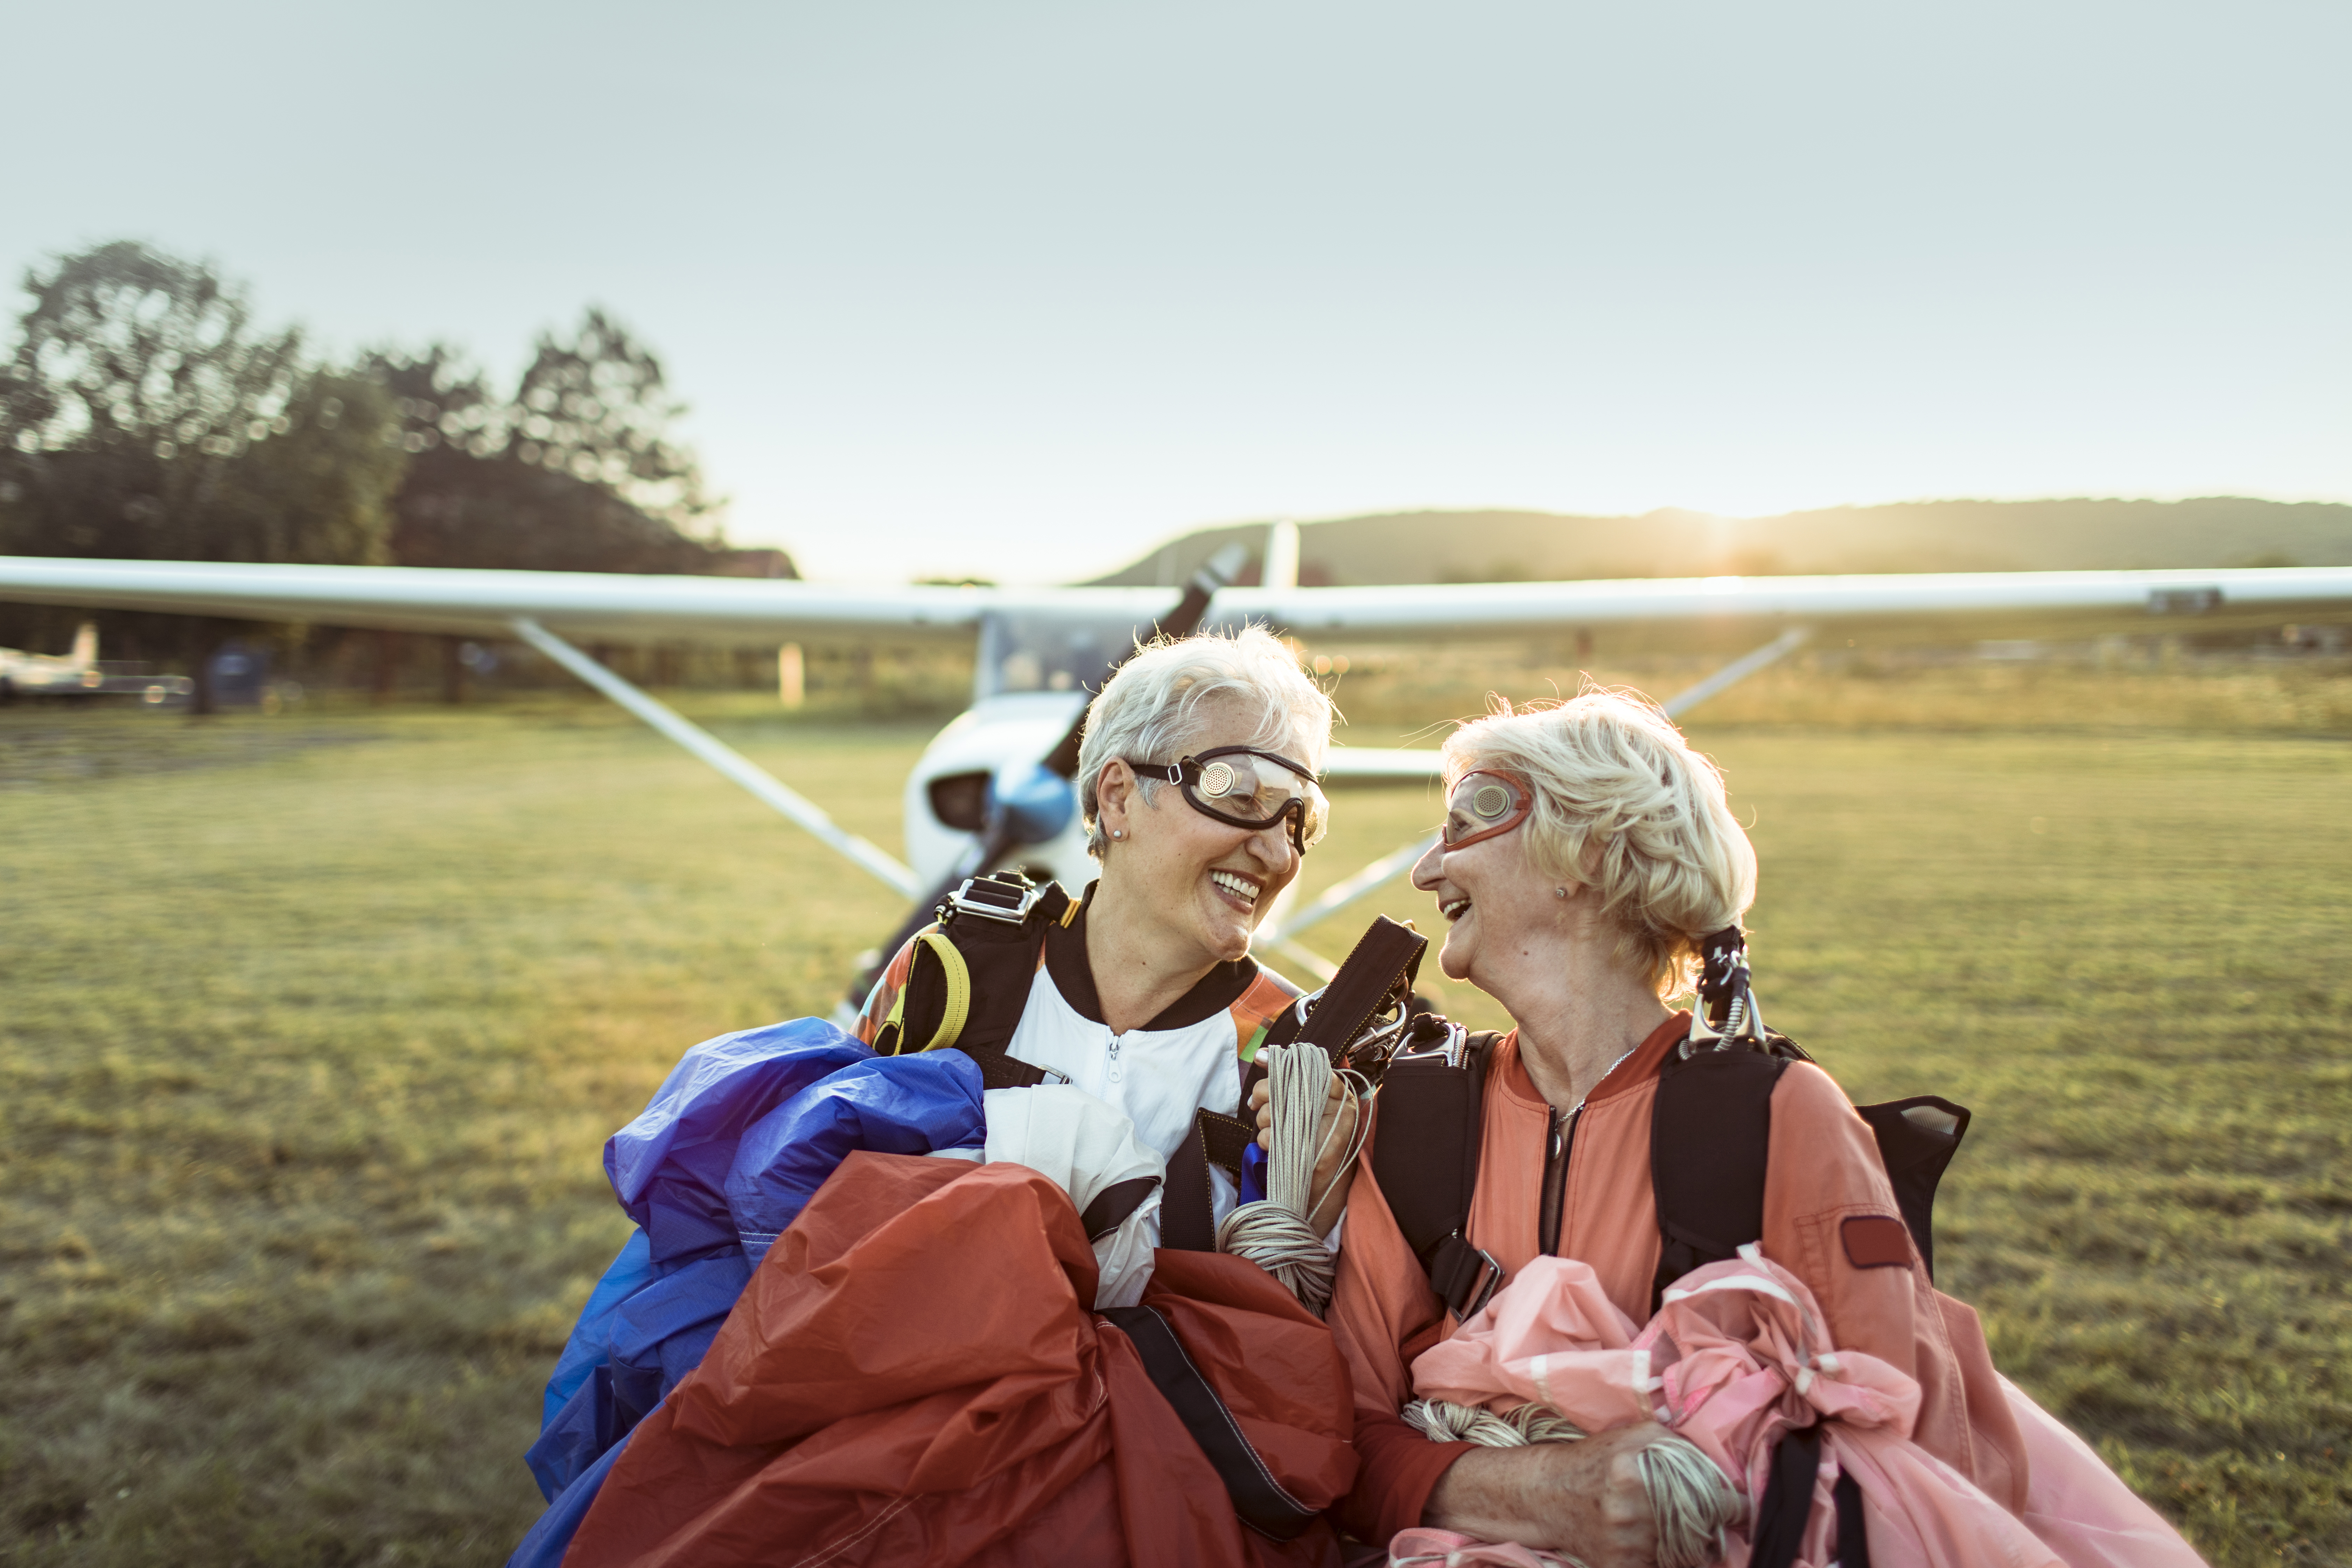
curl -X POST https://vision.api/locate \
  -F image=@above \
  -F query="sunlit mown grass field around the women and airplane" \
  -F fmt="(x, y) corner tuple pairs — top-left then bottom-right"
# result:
(0, 672), (2352, 1566)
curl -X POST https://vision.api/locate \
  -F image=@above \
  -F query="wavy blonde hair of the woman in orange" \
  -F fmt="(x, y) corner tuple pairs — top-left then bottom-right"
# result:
(1444, 686), (1757, 997)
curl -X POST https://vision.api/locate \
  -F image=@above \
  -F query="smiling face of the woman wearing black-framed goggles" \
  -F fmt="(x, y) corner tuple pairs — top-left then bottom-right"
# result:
(1101, 701), (1301, 964)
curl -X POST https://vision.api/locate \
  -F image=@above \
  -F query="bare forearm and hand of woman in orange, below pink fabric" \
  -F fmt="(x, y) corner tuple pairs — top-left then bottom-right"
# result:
(1423, 1422), (1665, 1568)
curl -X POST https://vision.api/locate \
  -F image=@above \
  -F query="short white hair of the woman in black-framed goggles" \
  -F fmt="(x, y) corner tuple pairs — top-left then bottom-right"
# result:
(1077, 625), (1338, 860)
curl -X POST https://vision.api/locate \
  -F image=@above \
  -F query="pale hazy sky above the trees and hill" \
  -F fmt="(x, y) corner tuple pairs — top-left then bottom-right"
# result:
(0, 0), (2352, 581)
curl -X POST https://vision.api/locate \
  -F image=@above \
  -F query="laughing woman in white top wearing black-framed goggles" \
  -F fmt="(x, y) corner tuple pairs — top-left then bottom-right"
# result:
(856, 628), (1355, 1223)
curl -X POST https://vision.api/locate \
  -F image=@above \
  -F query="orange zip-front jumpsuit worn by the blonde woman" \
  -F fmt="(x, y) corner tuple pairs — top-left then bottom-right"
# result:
(1329, 1013), (2025, 1542)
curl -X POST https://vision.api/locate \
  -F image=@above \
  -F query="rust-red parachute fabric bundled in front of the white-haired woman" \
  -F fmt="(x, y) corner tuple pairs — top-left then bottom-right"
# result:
(565, 1154), (1355, 1568)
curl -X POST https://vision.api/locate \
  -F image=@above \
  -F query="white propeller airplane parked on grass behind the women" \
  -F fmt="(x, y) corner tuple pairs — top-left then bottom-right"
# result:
(0, 533), (2352, 973)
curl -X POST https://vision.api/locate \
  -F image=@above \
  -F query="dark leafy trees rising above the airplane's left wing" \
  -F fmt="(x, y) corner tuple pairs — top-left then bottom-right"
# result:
(0, 240), (771, 691)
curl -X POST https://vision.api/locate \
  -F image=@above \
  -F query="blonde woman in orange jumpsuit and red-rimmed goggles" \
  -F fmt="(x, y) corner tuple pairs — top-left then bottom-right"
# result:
(1331, 689), (2197, 1568)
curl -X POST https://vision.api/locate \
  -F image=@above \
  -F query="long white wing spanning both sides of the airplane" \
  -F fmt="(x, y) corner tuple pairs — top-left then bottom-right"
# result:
(14, 555), (2352, 644)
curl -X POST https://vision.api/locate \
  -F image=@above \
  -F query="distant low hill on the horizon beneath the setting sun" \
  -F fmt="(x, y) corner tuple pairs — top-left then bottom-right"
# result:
(1096, 496), (2352, 585)
